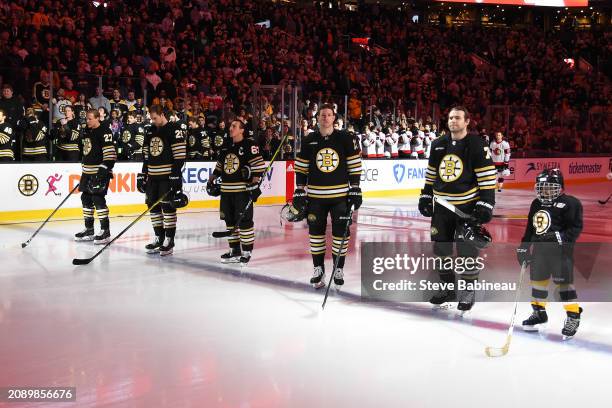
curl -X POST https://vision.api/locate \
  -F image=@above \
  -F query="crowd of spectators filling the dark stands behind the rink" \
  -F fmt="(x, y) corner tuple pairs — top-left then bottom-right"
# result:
(0, 0), (612, 163)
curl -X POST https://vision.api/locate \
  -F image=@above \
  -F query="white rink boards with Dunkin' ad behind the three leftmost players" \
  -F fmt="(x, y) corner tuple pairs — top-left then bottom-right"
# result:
(0, 162), (285, 219)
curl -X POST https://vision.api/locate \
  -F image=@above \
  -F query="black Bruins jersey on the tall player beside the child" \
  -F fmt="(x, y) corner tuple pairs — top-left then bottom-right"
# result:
(422, 134), (497, 206)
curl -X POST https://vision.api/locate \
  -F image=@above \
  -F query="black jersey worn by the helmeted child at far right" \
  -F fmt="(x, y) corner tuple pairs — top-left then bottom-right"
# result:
(521, 194), (582, 243)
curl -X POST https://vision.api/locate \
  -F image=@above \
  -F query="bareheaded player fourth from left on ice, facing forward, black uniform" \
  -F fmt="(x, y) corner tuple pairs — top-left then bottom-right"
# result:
(293, 104), (362, 288)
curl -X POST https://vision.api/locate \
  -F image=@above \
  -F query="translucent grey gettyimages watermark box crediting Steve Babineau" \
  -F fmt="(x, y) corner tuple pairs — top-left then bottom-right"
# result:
(361, 242), (612, 302)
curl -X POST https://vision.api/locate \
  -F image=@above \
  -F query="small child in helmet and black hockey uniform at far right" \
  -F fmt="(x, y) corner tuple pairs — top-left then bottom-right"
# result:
(516, 169), (582, 339)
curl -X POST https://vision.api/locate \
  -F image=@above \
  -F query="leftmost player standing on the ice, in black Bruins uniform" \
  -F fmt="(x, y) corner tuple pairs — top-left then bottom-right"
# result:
(74, 109), (117, 244)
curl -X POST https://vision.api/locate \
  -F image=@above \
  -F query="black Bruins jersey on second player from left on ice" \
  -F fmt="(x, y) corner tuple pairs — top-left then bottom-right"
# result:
(142, 122), (187, 178)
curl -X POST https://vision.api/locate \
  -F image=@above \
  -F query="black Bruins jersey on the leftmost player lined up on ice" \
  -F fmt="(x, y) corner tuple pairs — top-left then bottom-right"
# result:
(81, 125), (117, 174)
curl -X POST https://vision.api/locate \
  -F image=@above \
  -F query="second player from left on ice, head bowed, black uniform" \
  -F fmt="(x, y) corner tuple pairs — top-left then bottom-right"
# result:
(137, 105), (187, 256)
